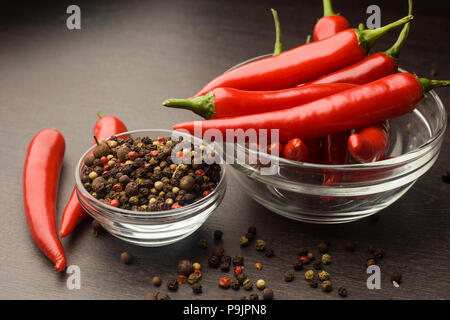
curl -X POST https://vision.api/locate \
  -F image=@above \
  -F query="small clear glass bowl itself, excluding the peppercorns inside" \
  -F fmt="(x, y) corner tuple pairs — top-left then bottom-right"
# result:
(75, 129), (226, 247)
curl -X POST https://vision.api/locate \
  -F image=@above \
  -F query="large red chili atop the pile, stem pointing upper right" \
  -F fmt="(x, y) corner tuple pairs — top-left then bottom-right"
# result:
(194, 16), (413, 97)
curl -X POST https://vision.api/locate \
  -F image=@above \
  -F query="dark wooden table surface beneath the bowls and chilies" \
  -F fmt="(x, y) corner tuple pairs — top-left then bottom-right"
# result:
(0, 0), (450, 299)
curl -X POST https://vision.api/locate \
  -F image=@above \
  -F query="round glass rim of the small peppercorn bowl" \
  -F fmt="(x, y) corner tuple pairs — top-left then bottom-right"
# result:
(75, 129), (226, 219)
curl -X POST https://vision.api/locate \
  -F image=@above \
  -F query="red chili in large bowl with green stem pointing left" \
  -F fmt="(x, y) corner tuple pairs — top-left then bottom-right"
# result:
(163, 83), (355, 119)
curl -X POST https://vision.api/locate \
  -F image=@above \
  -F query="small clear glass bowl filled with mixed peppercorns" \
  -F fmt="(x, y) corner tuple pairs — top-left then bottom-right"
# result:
(75, 129), (226, 247)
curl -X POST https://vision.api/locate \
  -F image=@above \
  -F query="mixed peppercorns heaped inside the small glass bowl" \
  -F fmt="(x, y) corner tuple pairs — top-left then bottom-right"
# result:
(81, 136), (221, 212)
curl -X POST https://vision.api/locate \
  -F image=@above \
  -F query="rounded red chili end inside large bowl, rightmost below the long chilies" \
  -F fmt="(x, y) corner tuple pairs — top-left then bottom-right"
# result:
(348, 120), (390, 163)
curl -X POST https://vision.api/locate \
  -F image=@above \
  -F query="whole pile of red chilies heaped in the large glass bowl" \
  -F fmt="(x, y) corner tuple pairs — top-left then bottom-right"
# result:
(168, 0), (450, 168)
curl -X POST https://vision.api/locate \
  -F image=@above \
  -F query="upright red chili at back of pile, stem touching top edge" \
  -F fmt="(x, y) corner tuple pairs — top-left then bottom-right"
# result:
(313, 0), (350, 41)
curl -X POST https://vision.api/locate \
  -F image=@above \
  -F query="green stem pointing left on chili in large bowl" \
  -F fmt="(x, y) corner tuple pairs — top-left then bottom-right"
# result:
(163, 91), (215, 119)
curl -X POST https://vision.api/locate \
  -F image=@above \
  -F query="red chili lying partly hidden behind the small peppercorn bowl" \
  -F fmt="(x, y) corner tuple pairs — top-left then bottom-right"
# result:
(59, 112), (128, 238)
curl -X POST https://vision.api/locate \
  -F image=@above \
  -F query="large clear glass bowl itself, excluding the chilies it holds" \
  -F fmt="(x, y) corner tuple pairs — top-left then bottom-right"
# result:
(227, 56), (447, 224)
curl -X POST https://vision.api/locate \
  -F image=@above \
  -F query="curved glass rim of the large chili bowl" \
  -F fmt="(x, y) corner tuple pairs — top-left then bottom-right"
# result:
(230, 54), (447, 171)
